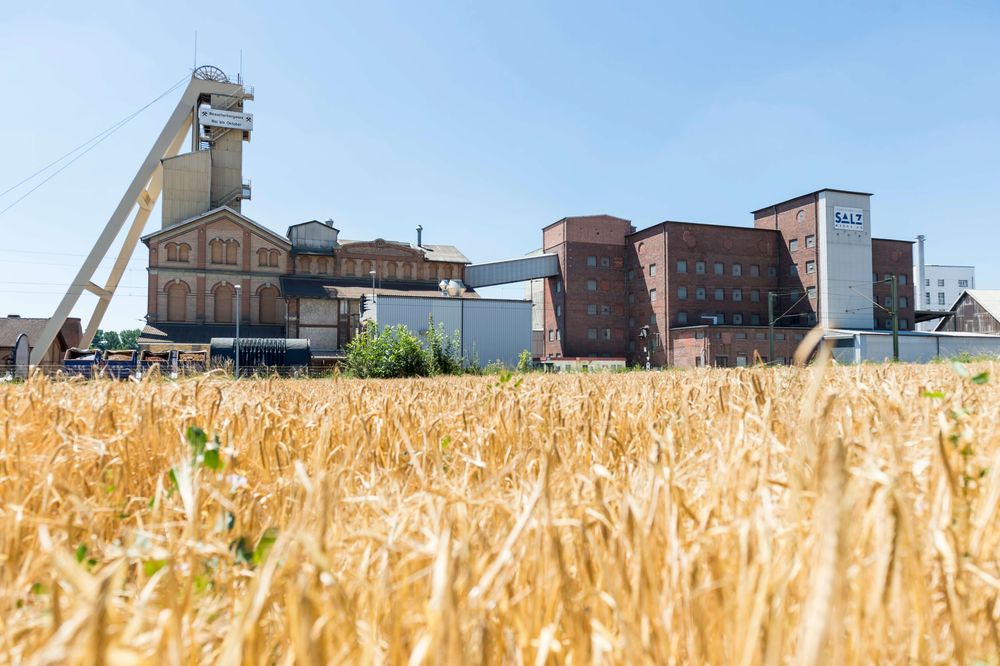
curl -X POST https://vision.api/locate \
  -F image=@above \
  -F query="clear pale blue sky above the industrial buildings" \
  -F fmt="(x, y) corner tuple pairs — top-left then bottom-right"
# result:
(0, 1), (1000, 328)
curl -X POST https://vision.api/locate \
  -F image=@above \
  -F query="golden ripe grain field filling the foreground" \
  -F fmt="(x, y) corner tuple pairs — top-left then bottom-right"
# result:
(0, 363), (1000, 666)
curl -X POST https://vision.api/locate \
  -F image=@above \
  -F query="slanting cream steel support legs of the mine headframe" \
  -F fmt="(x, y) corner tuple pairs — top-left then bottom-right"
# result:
(30, 78), (233, 365)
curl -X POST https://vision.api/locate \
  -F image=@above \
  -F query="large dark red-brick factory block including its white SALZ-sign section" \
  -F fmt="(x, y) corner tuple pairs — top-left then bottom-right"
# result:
(542, 189), (914, 366)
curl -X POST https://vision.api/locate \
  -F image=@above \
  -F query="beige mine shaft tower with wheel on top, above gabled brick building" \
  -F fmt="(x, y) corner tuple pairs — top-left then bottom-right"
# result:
(162, 67), (253, 229)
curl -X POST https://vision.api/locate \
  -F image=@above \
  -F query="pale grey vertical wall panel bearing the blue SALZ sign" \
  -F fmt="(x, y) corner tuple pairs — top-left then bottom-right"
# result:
(816, 190), (874, 329)
